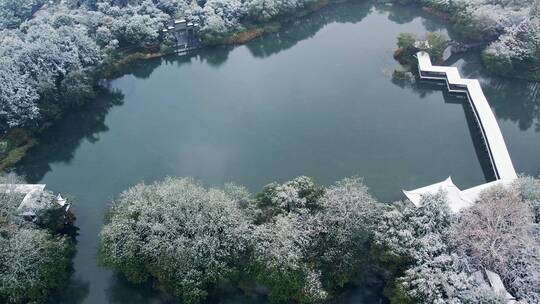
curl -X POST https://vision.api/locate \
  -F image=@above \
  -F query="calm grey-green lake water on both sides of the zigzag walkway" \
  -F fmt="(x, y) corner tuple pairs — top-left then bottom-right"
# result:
(17, 3), (540, 303)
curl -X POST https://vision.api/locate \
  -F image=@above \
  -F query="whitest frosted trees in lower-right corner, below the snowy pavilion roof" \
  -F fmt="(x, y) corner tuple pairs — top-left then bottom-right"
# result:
(375, 178), (540, 303)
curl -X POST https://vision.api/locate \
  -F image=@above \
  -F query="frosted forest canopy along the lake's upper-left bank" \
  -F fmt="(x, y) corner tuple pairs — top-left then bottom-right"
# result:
(0, 0), (334, 131)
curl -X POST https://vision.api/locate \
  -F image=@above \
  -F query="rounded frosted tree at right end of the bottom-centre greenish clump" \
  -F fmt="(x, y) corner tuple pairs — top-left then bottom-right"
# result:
(312, 177), (382, 289)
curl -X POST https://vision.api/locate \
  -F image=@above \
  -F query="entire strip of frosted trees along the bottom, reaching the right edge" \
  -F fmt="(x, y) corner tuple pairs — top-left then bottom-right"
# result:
(99, 177), (540, 303)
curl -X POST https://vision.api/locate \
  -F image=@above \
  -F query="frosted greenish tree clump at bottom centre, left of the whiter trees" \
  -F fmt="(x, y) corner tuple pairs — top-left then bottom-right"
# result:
(100, 176), (378, 303)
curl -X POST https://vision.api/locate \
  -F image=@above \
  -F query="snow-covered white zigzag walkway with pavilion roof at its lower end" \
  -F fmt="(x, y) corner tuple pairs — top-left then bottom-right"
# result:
(403, 52), (517, 212)
